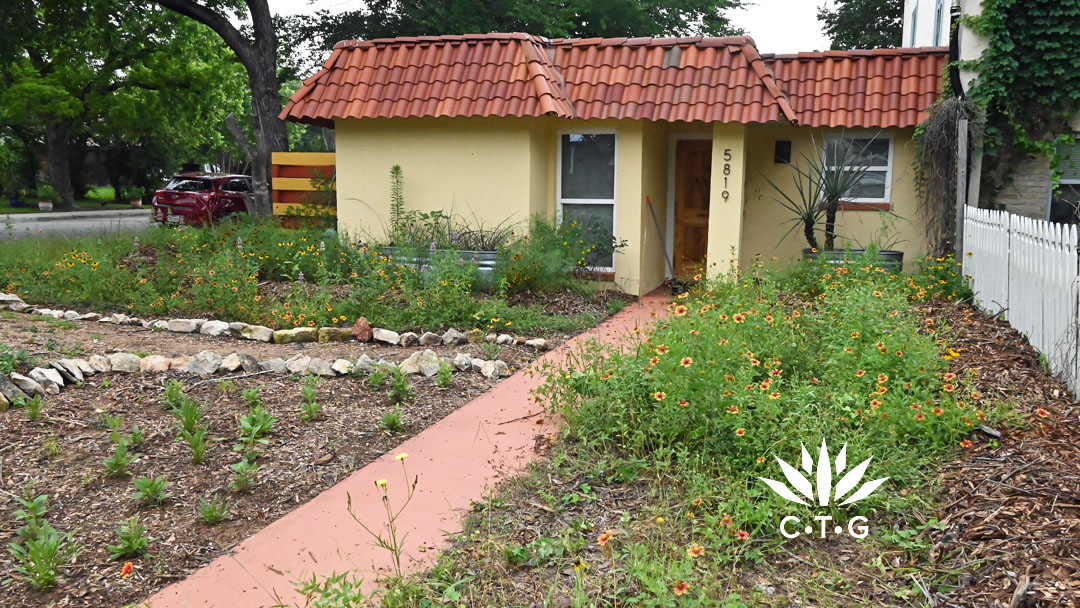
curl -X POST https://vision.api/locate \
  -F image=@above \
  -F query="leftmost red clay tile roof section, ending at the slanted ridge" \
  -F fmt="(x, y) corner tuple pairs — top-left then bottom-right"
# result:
(281, 33), (573, 126)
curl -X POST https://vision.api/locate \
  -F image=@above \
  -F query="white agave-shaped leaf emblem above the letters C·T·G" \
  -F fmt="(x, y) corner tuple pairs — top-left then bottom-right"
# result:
(758, 438), (889, 506)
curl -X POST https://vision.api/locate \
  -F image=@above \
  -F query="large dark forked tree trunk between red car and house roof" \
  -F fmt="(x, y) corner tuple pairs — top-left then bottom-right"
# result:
(154, 0), (288, 215)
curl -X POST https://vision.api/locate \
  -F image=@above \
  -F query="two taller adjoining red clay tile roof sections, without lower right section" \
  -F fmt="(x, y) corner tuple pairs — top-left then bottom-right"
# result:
(281, 33), (795, 125)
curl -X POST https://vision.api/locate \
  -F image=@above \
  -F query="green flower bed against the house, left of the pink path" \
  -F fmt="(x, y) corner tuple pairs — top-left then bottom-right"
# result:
(0, 219), (623, 334)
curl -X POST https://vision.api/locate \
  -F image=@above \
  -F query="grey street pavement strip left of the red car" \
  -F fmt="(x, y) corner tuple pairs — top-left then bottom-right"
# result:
(0, 208), (150, 241)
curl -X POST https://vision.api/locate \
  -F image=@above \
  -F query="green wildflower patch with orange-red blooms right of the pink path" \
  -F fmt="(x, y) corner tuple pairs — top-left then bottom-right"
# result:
(317, 253), (993, 607)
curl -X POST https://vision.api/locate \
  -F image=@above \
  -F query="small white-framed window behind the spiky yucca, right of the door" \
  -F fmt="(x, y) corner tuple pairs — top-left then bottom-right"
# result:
(825, 133), (893, 203)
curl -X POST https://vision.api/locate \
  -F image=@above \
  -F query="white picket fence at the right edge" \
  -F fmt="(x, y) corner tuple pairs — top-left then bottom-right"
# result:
(963, 206), (1080, 395)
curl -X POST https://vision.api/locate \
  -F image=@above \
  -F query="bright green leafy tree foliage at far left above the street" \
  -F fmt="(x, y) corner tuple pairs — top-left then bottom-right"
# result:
(0, 0), (243, 205)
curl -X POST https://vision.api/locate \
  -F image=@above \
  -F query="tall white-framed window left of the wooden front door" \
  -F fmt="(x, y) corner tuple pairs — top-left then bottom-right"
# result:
(558, 133), (616, 270)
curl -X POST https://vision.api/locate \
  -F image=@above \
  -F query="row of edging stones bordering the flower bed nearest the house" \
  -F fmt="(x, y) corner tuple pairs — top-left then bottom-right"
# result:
(0, 294), (549, 351)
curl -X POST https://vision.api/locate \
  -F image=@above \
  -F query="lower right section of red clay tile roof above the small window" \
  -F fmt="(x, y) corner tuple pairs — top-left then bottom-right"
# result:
(764, 46), (948, 127)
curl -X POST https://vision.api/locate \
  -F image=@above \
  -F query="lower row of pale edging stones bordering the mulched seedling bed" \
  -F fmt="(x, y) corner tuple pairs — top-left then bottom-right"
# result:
(0, 349), (510, 411)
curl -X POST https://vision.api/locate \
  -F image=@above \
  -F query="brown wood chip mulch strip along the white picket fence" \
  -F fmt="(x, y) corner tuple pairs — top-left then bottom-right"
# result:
(927, 305), (1080, 608)
